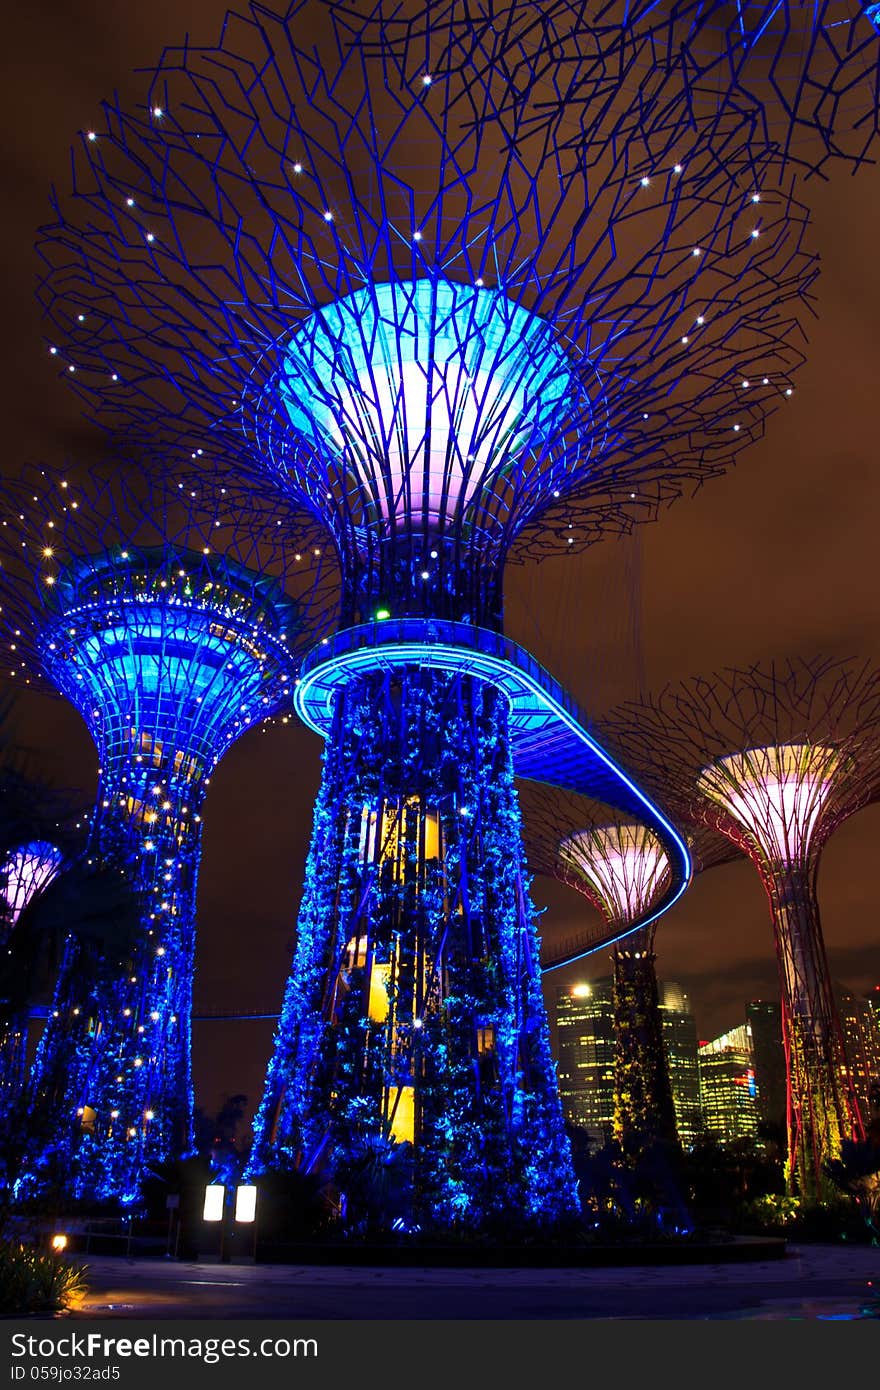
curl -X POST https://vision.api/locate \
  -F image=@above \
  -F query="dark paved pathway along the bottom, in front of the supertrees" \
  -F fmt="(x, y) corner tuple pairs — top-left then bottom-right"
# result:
(75, 1245), (880, 1319)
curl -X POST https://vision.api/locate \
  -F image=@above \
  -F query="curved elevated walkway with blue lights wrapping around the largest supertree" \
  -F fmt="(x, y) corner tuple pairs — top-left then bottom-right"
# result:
(293, 619), (694, 970)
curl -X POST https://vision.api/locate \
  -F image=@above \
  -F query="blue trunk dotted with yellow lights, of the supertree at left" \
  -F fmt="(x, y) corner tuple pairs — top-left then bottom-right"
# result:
(17, 763), (203, 1201)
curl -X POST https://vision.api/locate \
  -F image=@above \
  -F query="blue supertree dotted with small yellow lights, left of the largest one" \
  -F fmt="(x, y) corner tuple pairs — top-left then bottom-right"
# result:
(0, 471), (332, 1201)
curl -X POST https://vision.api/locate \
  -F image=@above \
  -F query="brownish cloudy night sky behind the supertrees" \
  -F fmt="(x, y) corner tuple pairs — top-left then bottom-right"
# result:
(0, 0), (880, 1109)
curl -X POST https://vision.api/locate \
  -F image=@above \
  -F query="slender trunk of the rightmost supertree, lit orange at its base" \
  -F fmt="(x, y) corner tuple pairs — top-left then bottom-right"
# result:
(765, 866), (862, 1201)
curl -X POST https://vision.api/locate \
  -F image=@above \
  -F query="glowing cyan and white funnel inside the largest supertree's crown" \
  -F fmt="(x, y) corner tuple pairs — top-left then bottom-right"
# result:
(275, 279), (573, 527)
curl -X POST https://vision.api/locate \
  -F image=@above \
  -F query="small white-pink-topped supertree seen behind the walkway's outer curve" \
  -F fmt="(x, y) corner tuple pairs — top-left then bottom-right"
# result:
(523, 788), (735, 1162)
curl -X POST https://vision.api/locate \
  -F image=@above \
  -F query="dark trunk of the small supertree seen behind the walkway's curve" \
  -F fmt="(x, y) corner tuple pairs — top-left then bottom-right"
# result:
(613, 929), (678, 1163)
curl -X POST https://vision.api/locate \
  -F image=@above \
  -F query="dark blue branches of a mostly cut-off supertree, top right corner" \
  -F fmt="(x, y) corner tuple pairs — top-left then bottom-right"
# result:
(386, 0), (880, 177)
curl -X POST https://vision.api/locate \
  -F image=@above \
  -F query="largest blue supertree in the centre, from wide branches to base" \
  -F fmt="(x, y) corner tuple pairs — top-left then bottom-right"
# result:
(30, 3), (815, 1226)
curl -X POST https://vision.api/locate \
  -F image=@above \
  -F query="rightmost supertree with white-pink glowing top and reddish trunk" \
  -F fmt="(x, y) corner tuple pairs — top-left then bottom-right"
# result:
(602, 660), (880, 1200)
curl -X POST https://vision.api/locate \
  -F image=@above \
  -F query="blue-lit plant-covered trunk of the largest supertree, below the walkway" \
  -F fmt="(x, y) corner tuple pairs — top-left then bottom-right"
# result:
(248, 667), (577, 1229)
